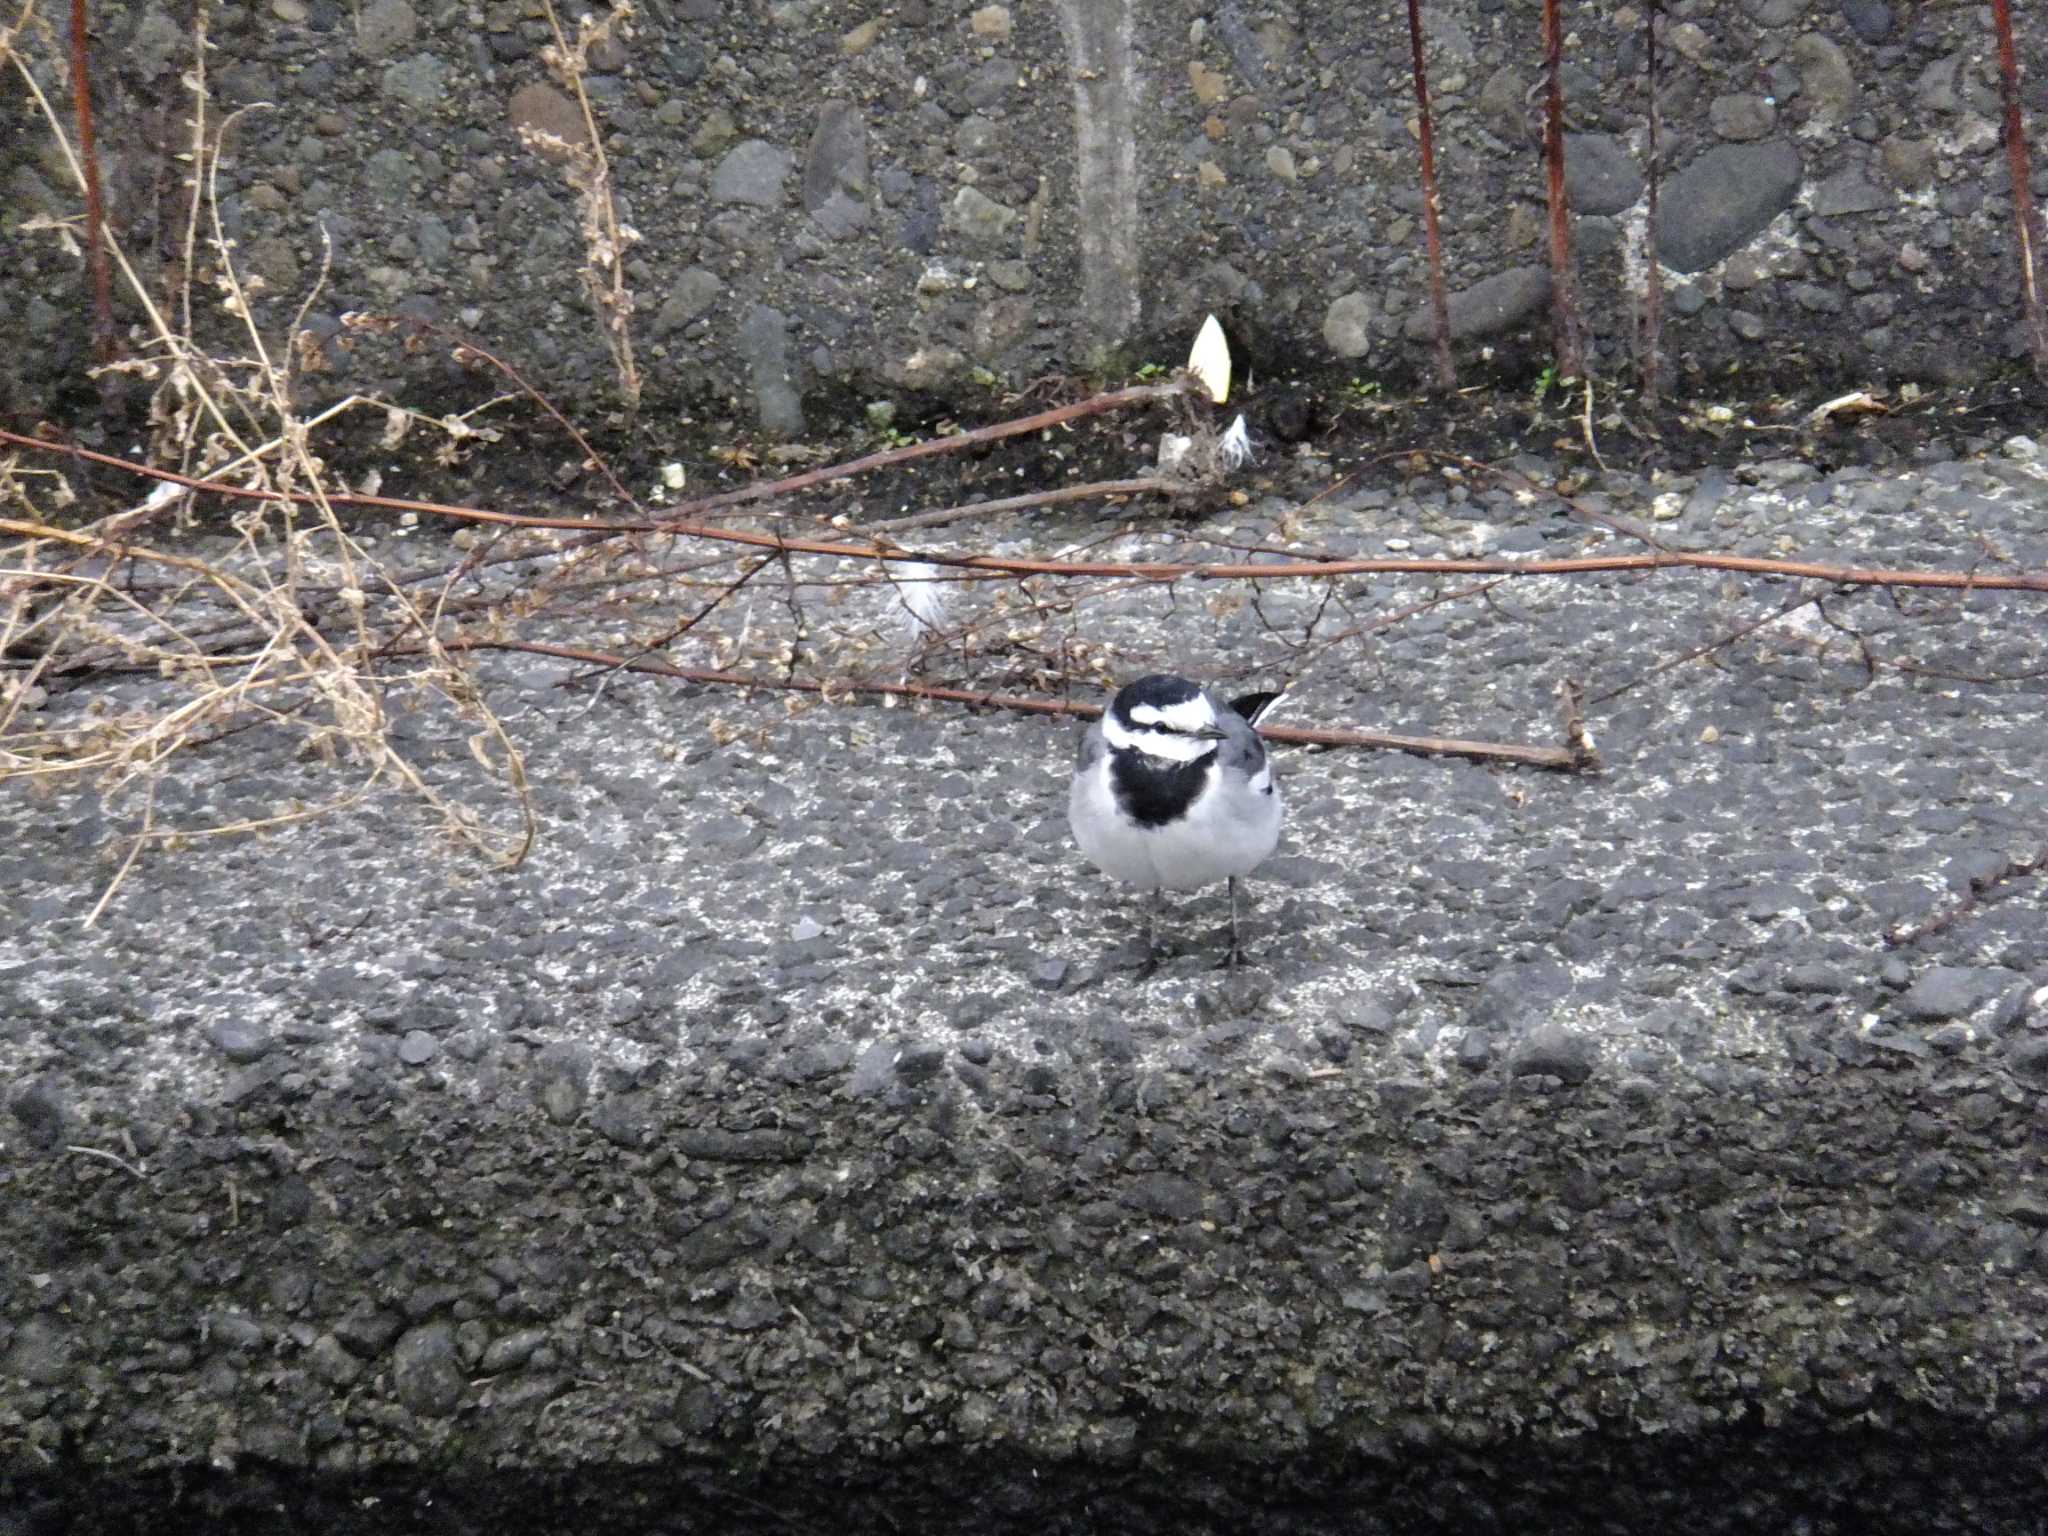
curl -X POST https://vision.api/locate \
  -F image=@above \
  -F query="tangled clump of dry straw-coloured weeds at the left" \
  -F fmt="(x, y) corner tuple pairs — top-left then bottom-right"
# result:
(0, 6), (535, 922)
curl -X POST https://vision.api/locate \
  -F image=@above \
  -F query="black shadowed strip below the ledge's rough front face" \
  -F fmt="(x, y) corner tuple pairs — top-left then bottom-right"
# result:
(0, 1417), (2048, 1536)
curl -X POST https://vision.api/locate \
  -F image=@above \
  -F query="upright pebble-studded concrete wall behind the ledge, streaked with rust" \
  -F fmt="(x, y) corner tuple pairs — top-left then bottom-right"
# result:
(0, 0), (2048, 434)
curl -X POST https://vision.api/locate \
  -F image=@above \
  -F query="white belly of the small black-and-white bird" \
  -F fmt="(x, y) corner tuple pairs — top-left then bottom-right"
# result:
(1067, 756), (1280, 891)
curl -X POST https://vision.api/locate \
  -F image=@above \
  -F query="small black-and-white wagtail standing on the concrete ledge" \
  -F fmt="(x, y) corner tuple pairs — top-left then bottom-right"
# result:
(1067, 672), (1280, 965)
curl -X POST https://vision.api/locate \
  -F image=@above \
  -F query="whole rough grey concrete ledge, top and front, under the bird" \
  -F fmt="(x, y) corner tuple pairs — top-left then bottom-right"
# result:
(0, 438), (2048, 1536)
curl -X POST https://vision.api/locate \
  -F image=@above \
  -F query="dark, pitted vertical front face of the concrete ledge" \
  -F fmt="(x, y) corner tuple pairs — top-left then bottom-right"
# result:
(0, 1055), (2048, 1530)
